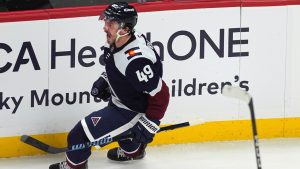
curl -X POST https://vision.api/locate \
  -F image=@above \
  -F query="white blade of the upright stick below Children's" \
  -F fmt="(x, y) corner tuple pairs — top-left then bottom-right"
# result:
(222, 85), (251, 103)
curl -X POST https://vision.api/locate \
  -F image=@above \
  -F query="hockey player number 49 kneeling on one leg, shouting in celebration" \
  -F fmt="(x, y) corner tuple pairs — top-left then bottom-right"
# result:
(49, 2), (170, 169)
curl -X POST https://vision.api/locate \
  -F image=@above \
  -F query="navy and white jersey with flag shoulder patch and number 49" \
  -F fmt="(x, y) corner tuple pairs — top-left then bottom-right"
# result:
(104, 33), (169, 119)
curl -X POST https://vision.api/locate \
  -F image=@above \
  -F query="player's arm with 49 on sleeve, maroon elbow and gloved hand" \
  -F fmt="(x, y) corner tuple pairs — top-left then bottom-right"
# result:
(126, 58), (170, 143)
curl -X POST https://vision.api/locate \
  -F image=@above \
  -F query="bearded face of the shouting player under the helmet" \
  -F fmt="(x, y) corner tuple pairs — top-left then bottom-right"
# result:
(103, 20), (120, 45)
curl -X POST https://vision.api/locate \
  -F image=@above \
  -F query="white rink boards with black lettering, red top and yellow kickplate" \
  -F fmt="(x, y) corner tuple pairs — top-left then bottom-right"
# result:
(0, 1), (300, 157)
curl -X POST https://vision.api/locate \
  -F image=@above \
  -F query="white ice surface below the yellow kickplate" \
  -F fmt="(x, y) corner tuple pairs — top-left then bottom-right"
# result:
(0, 138), (300, 169)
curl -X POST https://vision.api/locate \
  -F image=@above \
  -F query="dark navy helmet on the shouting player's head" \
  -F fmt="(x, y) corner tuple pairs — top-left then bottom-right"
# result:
(99, 2), (138, 31)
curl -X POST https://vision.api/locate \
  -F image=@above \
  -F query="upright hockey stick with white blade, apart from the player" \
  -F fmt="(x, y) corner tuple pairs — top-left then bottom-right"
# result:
(222, 85), (262, 169)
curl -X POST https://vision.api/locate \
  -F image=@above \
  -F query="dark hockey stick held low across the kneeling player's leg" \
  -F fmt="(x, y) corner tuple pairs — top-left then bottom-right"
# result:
(21, 120), (204, 154)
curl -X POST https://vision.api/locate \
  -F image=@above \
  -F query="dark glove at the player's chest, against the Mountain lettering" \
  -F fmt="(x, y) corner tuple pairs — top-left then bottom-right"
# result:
(91, 72), (111, 101)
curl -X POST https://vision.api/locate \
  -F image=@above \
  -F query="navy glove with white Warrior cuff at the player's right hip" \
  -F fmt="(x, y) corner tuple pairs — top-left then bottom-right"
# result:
(132, 115), (160, 144)
